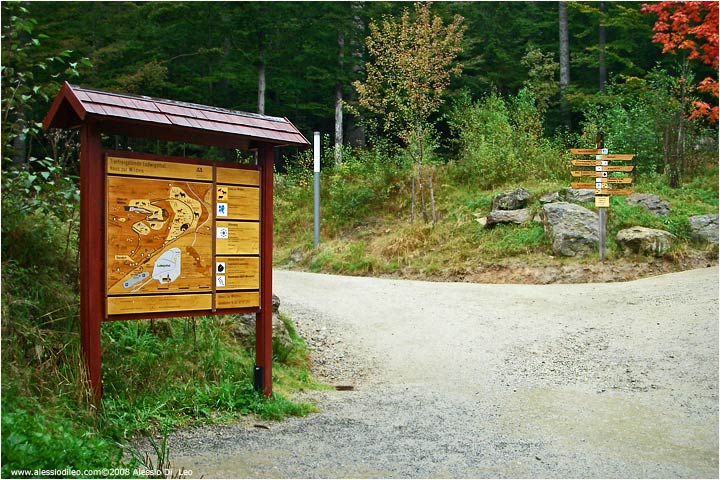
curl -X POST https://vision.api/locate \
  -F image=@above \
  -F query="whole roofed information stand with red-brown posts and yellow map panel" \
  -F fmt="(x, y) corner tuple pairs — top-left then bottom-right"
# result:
(43, 82), (309, 404)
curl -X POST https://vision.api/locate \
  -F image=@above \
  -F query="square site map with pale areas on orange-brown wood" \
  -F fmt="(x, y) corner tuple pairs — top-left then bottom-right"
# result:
(107, 175), (215, 295)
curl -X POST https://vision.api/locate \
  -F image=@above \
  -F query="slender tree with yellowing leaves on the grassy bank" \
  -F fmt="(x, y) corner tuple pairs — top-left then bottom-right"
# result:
(353, 2), (465, 224)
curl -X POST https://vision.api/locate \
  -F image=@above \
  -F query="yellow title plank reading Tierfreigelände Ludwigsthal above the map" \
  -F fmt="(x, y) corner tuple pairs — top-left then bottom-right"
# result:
(107, 156), (213, 182)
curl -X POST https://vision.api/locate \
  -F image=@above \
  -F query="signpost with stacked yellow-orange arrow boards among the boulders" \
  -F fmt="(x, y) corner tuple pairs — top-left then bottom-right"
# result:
(570, 132), (635, 261)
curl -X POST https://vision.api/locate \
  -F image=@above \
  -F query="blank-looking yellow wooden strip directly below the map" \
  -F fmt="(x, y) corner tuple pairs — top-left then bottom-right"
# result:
(107, 293), (212, 315)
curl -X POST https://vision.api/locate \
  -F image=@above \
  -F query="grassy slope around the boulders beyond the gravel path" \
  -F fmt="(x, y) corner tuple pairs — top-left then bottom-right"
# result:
(274, 148), (718, 280)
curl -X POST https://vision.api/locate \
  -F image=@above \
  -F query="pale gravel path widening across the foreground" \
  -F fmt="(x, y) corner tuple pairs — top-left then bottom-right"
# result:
(170, 267), (718, 478)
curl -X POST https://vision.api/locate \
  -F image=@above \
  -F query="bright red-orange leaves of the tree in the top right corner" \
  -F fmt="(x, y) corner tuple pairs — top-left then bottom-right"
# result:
(642, 1), (718, 123)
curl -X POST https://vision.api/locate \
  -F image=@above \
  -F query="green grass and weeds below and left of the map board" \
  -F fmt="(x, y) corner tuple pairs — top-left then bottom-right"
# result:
(2, 209), (318, 478)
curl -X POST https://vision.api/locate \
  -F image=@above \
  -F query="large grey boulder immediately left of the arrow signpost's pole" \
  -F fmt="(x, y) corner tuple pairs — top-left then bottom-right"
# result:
(540, 202), (600, 257)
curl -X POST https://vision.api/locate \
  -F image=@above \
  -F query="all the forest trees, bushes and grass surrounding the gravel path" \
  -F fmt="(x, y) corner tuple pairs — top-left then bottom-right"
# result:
(2, 1), (718, 478)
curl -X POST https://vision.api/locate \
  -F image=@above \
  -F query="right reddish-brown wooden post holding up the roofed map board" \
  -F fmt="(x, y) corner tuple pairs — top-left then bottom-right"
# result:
(255, 144), (275, 397)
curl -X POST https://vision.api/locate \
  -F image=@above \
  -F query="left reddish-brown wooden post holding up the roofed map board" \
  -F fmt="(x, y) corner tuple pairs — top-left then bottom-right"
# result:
(80, 123), (105, 406)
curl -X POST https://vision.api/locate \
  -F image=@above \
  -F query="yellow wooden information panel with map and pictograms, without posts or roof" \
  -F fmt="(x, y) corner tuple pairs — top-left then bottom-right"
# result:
(105, 155), (260, 319)
